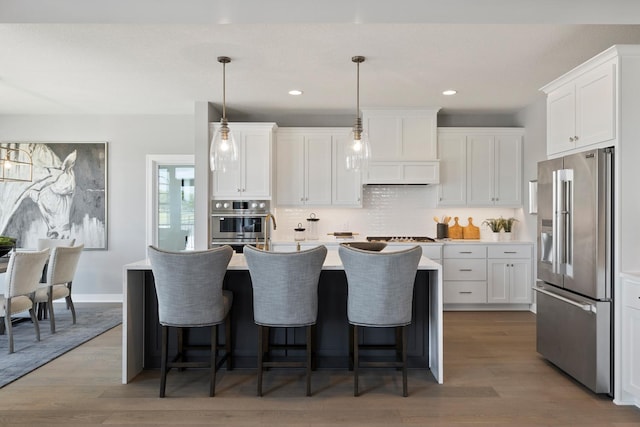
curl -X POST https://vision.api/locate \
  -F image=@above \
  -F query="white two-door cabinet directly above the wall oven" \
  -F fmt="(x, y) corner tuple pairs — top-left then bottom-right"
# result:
(210, 123), (276, 200)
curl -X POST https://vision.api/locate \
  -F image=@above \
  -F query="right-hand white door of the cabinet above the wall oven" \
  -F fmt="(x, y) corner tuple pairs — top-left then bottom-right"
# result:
(241, 131), (271, 199)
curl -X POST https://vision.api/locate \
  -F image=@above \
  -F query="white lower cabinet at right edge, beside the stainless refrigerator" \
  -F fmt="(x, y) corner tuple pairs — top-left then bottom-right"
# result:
(621, 274), (640, 407)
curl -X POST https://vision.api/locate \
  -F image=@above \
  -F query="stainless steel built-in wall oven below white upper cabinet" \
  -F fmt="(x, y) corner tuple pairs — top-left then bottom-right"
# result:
(210, 200), (271, 252)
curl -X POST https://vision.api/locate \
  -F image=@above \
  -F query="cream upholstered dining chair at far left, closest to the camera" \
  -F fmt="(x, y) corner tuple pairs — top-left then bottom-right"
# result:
(0, 249), (49, 353)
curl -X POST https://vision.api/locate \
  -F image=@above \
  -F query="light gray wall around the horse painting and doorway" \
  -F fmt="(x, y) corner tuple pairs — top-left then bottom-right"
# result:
(0, 115), (194, 301)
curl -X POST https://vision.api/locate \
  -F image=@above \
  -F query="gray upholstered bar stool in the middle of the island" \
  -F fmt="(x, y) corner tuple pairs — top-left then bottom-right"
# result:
(244, 246), (327, 396)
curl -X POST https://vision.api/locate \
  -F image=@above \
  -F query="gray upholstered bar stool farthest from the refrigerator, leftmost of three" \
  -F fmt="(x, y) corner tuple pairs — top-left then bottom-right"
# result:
(148, 246), (233, 397)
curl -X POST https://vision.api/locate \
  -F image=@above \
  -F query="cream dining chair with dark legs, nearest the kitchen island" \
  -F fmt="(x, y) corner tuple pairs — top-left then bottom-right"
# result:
(34, 245), (84, 334)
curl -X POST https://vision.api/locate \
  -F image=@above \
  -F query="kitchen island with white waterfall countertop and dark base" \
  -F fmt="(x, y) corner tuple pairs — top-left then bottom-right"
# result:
(122, 250), (443, 384)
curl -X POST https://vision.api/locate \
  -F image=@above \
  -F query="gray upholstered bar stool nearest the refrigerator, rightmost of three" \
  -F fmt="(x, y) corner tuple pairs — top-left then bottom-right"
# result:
(338, 245), (422, 397)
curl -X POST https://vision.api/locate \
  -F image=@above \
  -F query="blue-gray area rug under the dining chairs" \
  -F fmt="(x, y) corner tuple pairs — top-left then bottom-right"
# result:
(0, 304), (122, 388)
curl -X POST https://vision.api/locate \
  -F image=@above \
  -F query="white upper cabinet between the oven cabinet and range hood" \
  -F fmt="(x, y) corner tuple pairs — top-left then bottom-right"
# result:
(276, 127), (362, 207)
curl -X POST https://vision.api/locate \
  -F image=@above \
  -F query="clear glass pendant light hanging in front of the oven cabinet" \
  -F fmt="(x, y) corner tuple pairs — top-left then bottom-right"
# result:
(209, 56), (238, 172)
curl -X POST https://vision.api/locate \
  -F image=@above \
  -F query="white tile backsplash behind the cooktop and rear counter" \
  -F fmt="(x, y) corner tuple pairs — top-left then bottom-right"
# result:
(272, 185), (527, 241)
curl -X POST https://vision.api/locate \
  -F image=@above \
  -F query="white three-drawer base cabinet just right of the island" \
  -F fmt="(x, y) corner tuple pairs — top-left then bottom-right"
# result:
(442, 244), (487, 304)
